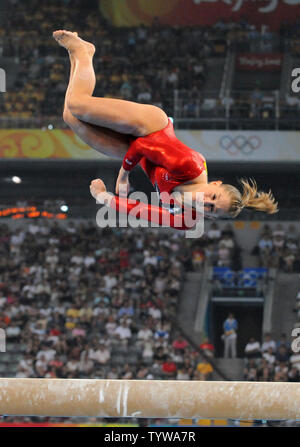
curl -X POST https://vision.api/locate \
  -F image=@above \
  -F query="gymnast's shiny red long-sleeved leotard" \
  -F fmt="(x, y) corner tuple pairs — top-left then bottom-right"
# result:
(110, 120), (207, 230)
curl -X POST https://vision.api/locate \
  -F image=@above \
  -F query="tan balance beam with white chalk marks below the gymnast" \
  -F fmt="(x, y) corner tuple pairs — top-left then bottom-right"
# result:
(0, 378), (300, 420)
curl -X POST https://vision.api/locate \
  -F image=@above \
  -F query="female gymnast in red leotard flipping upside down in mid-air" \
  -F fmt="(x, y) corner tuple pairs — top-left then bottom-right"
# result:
(53, 30), (278, 230)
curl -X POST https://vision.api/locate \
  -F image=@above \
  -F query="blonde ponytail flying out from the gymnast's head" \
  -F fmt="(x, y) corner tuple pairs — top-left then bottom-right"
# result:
(222, 179), (278, 217)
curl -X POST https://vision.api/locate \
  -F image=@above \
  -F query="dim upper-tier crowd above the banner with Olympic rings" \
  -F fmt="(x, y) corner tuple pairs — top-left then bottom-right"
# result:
(0, 0), (299, 126)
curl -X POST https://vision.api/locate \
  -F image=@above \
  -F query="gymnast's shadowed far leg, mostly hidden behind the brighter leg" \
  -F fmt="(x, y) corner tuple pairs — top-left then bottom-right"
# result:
(63, 35), (129, 159)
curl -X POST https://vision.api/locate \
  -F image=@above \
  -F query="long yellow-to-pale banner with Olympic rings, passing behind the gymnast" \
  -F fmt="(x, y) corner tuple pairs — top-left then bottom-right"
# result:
(0, 129), (300, 161)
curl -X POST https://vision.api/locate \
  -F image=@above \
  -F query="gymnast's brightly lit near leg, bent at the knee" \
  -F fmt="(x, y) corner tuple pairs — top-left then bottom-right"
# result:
(53, 30), (168, 137)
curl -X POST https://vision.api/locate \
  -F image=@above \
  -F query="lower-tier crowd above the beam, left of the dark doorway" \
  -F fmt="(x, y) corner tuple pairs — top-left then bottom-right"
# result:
(0, 221), (218, 380)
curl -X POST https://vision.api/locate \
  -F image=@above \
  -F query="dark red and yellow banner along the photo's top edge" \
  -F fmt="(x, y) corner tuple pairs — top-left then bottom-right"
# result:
(99, 0), (300, 30)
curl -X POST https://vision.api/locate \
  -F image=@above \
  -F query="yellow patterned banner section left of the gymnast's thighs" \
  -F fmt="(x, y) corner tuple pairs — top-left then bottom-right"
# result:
(0, 129), (107, 159)
